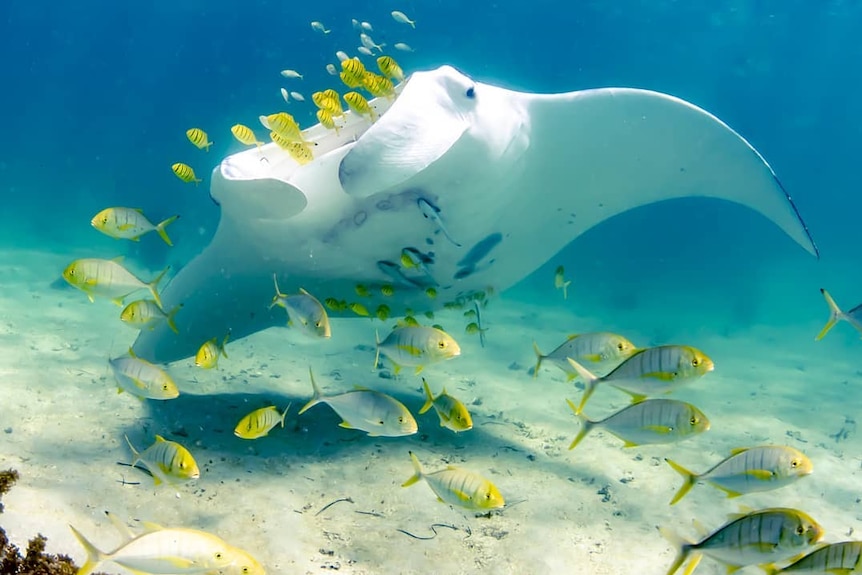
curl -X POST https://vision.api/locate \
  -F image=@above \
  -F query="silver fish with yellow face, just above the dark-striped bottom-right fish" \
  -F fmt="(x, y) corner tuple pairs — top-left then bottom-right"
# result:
(666, 445), (813, 505)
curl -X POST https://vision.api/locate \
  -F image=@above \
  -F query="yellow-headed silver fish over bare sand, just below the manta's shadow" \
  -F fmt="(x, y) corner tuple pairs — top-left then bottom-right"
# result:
(401, 451), (506, 511)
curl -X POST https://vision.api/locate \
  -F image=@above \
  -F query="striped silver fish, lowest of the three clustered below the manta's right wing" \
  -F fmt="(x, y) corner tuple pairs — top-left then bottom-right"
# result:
(568, 399), (710, 449)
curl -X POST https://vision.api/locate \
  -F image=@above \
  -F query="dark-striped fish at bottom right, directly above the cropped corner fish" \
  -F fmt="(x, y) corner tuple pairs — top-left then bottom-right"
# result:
(662, 508), (823, 575)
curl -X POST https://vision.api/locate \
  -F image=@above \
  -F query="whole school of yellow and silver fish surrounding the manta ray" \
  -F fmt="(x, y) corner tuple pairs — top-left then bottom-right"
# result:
(54, 11), (862, 575)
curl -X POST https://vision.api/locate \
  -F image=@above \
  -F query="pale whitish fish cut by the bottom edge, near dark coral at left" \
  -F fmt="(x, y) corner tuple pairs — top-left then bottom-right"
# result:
(71, 527), (266, 575)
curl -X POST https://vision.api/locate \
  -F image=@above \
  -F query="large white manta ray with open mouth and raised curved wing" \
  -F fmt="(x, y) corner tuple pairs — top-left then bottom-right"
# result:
(134, 66), (818, 362)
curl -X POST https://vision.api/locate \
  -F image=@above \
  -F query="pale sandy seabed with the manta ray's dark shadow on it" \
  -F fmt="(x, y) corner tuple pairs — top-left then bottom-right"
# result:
(0, 250), (862, 575)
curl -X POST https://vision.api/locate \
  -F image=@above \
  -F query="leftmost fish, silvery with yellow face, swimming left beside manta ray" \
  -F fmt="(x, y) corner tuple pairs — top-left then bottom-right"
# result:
(63, 258), (168, 307)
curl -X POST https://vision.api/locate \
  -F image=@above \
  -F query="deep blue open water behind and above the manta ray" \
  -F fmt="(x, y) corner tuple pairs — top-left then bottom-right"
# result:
(0, 0), (862, 572)
